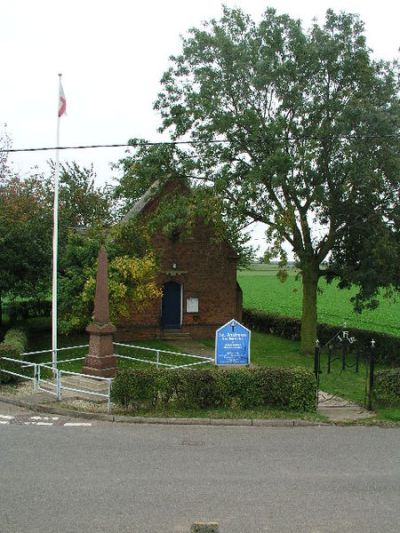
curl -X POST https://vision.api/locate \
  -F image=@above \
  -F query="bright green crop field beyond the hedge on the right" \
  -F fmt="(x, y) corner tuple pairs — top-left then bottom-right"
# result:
(238, 265), (400, 336)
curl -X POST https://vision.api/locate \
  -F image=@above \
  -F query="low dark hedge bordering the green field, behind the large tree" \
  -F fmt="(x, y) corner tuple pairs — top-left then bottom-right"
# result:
(243, 309), (400, 367)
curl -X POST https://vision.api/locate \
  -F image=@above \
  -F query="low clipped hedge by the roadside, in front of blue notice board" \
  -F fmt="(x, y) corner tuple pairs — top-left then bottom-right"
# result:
(112, 368), (316, 411)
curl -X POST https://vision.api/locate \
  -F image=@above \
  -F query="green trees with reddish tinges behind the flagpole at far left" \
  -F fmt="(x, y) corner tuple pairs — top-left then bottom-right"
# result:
(0, 156), (113, 326)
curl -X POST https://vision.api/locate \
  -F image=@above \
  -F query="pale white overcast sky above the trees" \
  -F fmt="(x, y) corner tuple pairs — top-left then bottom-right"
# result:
(0, 0), (400, 251)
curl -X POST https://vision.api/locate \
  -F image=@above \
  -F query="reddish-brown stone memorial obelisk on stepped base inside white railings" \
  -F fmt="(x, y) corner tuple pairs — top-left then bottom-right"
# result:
(82, 246), (117, 378)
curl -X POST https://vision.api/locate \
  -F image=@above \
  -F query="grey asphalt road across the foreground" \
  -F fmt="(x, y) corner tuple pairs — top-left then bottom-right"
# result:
(0, 422), (400, 533)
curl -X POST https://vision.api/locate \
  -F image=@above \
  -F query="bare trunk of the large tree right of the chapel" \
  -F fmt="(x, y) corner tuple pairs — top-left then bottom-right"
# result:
(301, 265), (319, 354)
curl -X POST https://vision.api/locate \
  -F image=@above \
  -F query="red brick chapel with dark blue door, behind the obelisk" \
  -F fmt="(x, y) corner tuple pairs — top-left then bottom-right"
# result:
(117, 177), (242, 341)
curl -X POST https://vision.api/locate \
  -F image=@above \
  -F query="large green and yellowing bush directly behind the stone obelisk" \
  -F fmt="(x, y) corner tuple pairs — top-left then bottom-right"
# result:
(59, 220), (160, 333)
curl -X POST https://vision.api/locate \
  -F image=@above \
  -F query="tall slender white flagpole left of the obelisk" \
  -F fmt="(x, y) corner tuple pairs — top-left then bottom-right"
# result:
(51, 74), (62, 371)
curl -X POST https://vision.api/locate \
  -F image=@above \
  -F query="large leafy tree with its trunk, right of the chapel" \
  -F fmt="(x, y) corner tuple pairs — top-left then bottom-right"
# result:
(155, 8), (400, 352)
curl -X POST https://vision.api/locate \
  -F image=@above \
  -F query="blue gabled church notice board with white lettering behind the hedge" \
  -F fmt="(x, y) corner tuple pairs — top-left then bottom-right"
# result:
(215, 320), (251, 365)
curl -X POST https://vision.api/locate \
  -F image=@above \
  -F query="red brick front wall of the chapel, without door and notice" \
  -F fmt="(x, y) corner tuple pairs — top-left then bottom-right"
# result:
(117, 183), (241, 340)
